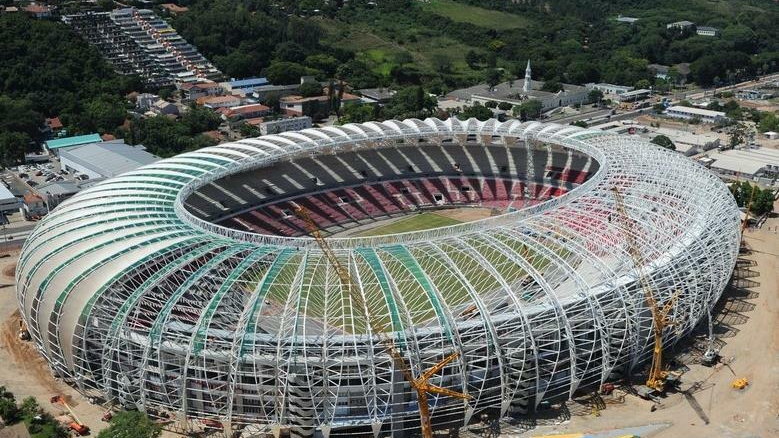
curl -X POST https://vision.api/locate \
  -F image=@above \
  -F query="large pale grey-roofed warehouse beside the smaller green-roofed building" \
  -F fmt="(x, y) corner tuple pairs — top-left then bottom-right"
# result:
(60, 140), (159, 179)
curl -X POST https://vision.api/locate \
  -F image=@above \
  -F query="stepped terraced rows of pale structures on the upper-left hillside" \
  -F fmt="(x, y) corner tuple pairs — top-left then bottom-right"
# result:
(62, 8), (222, 87)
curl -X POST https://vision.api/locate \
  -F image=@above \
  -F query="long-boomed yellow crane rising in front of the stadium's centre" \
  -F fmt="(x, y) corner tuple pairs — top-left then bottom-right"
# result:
(294, 205), (472, 438)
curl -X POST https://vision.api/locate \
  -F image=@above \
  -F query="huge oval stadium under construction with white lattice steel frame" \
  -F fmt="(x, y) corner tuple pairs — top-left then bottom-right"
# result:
(16, 118), (740, 437)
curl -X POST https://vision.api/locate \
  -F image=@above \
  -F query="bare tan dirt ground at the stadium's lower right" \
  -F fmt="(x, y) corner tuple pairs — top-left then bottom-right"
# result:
(520, 205), (779, 438)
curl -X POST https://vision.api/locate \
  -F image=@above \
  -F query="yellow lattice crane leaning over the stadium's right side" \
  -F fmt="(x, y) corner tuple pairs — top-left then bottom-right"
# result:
(612, 187), (679, 392)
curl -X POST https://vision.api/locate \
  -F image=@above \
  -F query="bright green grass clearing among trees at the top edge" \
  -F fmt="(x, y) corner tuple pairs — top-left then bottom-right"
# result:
(420, 0), (527, 30)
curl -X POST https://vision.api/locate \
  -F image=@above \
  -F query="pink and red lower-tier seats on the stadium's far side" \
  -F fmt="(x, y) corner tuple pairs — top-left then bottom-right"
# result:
(216, 172), (586, 236)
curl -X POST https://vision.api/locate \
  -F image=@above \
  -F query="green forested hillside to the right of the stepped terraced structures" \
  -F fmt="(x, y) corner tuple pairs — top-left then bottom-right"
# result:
(175, 0), (779, 92)
